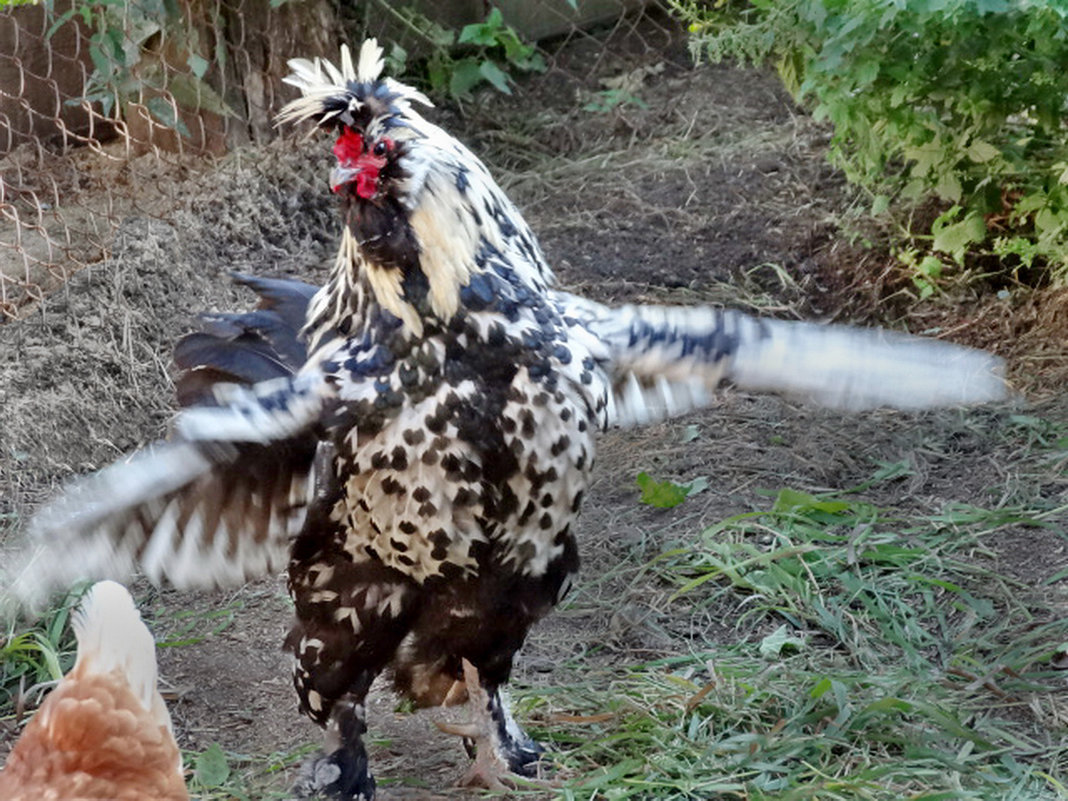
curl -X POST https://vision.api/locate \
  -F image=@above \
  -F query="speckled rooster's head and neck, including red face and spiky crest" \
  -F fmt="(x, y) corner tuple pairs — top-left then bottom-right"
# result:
(279, 40), (551, 333)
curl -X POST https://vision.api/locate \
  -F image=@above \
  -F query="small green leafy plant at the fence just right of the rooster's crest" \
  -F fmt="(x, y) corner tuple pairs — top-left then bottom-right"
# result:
(379, 0), (546, 99)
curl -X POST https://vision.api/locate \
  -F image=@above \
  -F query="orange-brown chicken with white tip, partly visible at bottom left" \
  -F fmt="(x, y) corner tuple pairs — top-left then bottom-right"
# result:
(0, 581), (189, 801)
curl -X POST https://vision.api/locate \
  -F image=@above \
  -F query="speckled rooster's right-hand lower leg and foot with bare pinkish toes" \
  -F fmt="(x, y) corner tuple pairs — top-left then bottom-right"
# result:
(438, 659), (545, 790)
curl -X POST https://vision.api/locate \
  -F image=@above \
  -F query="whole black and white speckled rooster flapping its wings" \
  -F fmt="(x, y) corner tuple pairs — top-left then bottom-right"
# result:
(10, 41), (1006, 799)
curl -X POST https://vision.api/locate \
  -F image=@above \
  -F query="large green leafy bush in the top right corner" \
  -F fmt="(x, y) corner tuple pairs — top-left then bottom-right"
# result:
(673, 0), (1068, 292)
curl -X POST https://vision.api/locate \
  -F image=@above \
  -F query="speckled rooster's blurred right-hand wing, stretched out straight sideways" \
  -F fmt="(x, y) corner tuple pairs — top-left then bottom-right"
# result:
(566, 296), (1009, 425)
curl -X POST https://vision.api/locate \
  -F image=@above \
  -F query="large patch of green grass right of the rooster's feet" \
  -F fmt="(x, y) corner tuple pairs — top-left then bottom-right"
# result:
(521, 418), (1068, 801)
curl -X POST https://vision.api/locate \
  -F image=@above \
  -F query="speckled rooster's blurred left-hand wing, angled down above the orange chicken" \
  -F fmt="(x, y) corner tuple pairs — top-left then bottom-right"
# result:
(12, 375), (333, 606)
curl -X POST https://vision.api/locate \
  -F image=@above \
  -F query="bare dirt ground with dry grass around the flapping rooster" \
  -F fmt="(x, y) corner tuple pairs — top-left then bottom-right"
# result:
(0, 12), (1068, 801)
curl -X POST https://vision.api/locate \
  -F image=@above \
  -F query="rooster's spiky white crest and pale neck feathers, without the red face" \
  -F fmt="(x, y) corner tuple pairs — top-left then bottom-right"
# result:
(279, 40), (553, 350)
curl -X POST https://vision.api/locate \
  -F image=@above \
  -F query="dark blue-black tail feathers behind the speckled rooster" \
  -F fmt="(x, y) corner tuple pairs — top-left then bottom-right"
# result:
(174, 272), (317, 406)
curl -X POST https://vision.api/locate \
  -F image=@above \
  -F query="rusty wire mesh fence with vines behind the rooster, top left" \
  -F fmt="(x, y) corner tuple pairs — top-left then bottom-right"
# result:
(0, 0), (656, 324)
